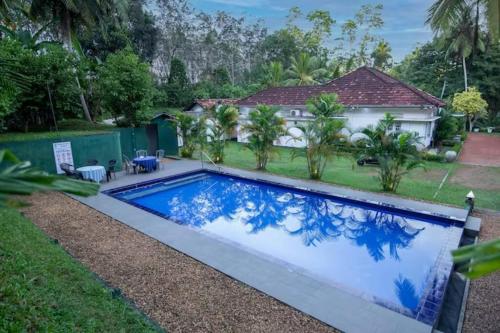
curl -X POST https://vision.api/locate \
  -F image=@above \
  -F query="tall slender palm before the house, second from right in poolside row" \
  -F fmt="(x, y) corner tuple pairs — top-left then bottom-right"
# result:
(292, 94), (345, 179)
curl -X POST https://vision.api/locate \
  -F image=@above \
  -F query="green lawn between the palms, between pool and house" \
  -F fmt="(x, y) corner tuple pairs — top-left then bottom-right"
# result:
(219, 142), (500, 210)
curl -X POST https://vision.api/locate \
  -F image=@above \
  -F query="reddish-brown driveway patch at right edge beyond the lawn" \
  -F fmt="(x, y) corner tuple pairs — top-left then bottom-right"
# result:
(459, 133), (500, 167)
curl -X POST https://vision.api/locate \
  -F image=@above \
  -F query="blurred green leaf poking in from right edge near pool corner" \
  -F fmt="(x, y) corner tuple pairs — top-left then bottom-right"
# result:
(452, 239), (500, 279)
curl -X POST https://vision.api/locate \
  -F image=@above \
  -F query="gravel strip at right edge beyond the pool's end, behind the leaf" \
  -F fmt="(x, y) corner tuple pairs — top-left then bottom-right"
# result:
(463, 213), (500, 333)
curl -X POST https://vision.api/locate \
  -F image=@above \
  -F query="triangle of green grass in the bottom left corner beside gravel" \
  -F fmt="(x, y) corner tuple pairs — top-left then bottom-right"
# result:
(0, 209), (159, 332)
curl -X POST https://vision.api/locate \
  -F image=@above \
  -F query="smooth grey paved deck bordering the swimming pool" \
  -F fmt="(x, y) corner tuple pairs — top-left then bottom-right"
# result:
(75, 160), (467, 332)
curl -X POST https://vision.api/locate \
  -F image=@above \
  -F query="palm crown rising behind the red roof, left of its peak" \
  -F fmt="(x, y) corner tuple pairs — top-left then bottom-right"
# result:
(286, 53), (327, 86)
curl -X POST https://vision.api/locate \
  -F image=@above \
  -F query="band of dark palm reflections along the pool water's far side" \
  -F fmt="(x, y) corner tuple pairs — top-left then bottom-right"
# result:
(168, 177), (422, 261)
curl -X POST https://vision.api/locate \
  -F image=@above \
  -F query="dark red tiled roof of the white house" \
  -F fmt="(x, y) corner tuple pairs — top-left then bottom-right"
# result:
(237, 66), (445, 107)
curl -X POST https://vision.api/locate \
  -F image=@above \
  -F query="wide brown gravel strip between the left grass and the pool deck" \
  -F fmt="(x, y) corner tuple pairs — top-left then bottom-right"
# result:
(24, 193), (334, 332)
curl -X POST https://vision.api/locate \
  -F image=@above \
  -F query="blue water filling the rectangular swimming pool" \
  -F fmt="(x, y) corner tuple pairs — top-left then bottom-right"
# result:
(111, 172), (462, 324)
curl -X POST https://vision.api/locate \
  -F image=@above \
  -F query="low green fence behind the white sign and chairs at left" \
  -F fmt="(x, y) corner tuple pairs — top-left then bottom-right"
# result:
(0, 132), (122, 173)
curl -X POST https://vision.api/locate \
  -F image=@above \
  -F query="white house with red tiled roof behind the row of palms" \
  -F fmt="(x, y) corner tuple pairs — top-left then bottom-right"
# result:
(237, 66), (445, 147)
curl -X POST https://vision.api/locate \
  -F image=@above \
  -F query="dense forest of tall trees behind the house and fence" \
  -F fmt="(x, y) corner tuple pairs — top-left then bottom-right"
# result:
(0, 0), (500, 131)
